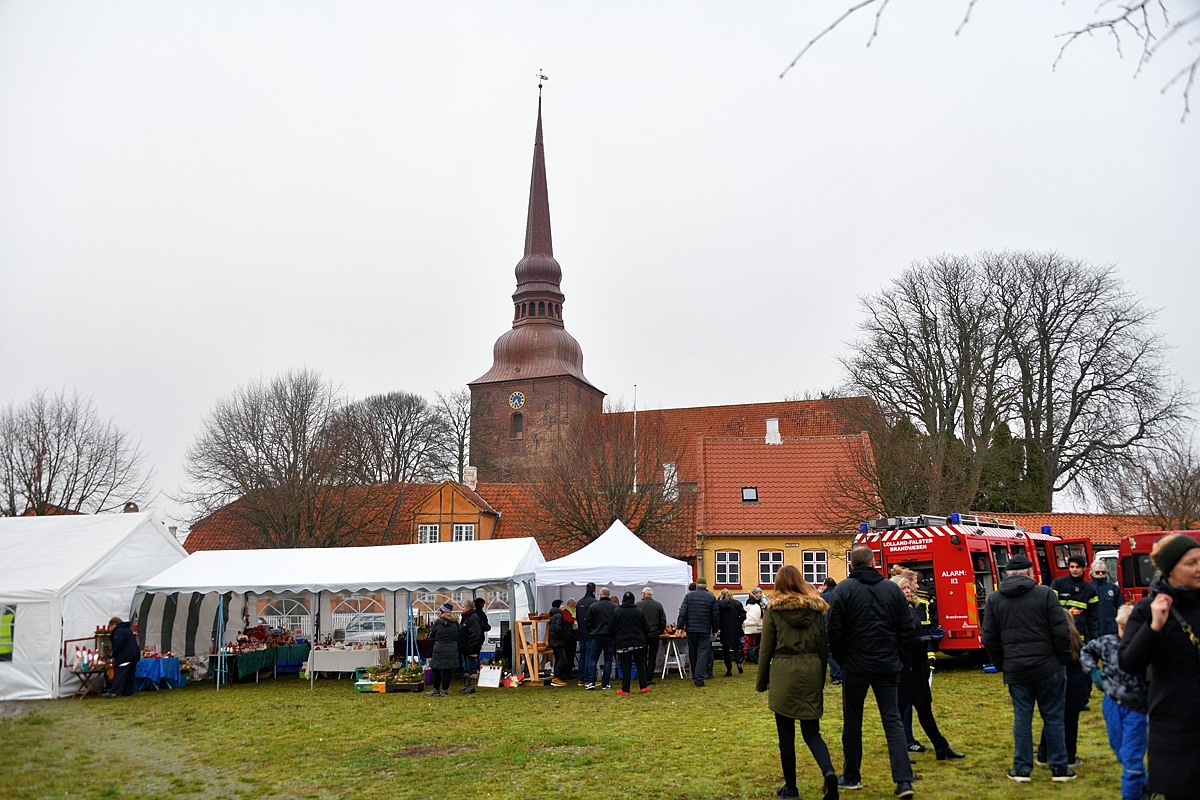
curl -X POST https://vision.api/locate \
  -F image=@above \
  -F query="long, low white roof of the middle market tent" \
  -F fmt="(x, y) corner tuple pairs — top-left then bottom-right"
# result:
(138, 539), (545, 593)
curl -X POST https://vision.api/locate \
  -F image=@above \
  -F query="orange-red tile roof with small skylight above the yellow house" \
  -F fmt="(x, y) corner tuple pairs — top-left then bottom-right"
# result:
(696, 434), (870, 534)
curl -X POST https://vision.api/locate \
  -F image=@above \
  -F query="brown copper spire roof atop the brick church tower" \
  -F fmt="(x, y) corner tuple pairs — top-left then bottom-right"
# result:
(472, 97), (592, 386)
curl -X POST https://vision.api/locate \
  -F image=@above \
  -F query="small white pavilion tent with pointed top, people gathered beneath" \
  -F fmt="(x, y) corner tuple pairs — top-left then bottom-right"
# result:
(538, 519), (691, 622)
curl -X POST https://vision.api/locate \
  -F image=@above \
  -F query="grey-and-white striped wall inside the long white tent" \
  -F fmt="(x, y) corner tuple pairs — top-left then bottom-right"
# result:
(136, 591), (246, 656)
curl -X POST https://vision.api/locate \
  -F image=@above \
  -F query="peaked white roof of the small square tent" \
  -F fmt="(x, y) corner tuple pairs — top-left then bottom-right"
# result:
(538, 519), (691, 585)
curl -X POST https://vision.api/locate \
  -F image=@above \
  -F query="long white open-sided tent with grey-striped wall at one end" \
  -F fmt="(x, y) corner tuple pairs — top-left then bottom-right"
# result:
(138, 539), (545, 655)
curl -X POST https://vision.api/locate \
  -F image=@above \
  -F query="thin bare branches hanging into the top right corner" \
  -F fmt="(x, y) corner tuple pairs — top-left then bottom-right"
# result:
(779, 0), (1200, 119)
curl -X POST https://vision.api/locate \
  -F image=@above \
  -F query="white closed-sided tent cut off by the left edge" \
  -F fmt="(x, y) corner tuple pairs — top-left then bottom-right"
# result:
(0, 513), (187, 700)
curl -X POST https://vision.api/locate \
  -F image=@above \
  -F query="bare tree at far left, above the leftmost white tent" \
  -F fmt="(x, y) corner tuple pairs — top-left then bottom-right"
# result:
(0, 390), (152, 516)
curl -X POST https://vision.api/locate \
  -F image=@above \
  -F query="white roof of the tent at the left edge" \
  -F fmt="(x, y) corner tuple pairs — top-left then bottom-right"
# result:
(0, 513), (185, 599)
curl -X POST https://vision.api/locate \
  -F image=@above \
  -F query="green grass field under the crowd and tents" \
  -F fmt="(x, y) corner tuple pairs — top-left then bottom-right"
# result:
(0, 664), (1120, 800)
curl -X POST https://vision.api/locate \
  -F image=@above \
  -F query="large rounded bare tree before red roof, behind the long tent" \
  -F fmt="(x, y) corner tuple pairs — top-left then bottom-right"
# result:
(180, 371), (402, 547)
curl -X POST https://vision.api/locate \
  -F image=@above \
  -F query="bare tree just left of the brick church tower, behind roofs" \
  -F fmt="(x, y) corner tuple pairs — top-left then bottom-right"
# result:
(341, 392), (449, 483)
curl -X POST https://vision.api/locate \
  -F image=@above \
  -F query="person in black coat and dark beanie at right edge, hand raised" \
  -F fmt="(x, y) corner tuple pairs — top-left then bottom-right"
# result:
(1117, 534), (1200, 798)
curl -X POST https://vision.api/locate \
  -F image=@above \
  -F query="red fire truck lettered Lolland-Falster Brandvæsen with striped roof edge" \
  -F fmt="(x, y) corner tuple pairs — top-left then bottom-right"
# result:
(854, 513), (1092, 655)
